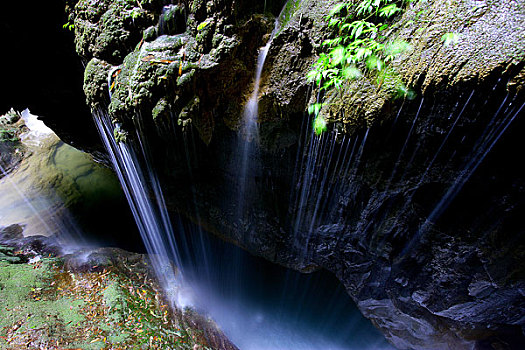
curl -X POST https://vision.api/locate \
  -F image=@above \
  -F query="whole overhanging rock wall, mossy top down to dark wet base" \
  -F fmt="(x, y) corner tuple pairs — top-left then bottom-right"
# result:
(64, 0), (525, 349)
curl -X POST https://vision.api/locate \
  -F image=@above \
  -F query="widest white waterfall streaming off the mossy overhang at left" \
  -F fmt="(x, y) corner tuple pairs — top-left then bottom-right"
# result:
(93, 111), (187, 306)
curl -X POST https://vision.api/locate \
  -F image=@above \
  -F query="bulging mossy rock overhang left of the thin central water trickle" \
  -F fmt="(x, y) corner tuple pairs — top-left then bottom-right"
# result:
(73, 0), (282, 143)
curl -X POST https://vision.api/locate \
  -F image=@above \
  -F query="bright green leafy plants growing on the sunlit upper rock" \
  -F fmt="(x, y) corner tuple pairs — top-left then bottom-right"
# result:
(307, 0), (412, 133)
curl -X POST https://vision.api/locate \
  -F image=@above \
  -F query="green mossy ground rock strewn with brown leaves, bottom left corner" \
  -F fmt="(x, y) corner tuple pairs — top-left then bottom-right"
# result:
(0, 246), (235, 350)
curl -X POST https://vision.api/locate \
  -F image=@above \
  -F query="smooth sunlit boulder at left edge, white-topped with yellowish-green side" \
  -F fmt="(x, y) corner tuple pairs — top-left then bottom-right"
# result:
(0, 110), (139, 247)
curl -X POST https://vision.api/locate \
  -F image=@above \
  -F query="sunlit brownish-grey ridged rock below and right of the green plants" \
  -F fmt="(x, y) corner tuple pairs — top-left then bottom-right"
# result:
(323, 0), (525, 130)
